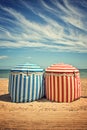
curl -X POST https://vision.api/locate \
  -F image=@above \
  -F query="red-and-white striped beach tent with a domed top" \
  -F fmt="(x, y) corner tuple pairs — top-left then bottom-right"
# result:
(45, 64), (81, 102)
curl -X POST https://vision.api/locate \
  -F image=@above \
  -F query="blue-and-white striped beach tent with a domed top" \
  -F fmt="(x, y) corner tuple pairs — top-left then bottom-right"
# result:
(9, 64), (44, 102)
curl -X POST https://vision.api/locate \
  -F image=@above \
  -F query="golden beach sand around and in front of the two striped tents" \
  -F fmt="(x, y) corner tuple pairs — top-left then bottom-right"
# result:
(0, 79), (87, 130)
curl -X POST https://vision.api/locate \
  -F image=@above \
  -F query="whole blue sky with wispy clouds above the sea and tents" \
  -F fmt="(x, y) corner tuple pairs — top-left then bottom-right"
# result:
(0, 0), (87, 69)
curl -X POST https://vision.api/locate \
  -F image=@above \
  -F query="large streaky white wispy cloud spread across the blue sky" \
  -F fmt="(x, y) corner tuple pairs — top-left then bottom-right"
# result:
(0, 0), (87, 52)
